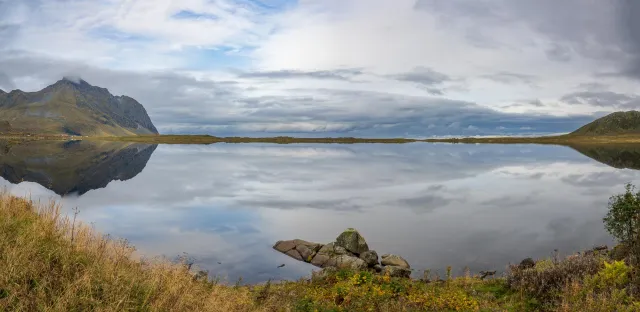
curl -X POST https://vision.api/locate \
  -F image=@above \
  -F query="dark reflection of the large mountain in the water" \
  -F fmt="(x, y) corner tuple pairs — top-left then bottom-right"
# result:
(0, 140), (157, 196)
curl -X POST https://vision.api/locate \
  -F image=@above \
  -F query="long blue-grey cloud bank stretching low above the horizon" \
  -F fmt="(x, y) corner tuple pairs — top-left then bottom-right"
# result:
(0, 51), (590, 136)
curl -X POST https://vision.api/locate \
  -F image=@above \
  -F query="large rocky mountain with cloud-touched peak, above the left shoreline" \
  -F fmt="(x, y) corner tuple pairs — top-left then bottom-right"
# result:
(0, 78), (158, 136)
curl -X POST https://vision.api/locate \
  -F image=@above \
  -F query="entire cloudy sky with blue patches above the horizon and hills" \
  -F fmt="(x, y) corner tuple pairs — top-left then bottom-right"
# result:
(0, 0), (640, 137)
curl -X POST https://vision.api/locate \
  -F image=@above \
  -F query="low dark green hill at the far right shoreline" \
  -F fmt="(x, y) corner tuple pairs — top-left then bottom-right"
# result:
(570, 111), (640, 136)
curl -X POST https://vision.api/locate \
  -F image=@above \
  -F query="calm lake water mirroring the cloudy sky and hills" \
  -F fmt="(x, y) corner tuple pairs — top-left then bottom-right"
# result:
(0, 142), (640, 282)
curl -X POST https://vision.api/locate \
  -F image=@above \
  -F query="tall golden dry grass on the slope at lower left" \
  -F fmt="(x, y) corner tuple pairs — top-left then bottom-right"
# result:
(0, 194), (254, 311)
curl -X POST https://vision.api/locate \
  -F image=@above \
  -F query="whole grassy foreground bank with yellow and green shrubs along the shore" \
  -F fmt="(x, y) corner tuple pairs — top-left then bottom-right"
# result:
(0, 194), (640, 311)
